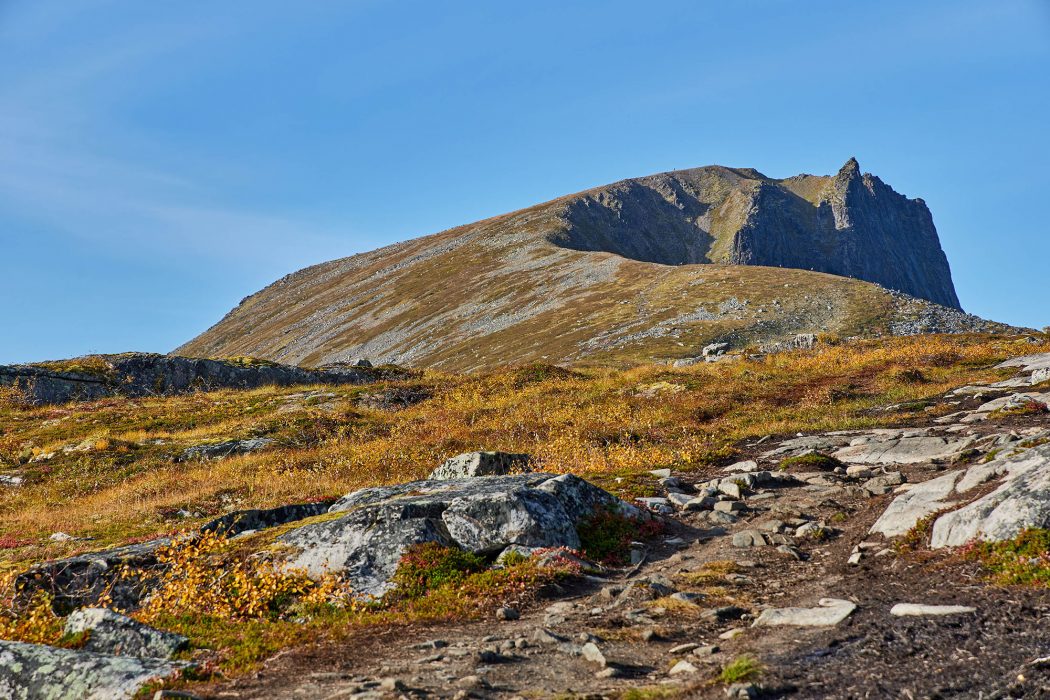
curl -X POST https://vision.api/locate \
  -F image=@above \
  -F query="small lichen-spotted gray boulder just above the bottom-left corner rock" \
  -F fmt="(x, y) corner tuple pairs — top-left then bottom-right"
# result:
(65, 608), (189, 659)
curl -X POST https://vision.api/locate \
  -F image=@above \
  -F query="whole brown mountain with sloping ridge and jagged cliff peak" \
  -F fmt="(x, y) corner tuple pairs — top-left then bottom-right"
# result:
(175, 158), (1005, 369)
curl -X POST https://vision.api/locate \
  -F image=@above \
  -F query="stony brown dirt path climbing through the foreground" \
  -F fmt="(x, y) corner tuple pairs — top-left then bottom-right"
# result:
(194, 386), (1050, 699)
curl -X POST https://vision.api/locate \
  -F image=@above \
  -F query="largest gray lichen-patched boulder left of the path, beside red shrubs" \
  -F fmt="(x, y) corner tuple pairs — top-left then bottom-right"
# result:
(277, 473), (646, 596)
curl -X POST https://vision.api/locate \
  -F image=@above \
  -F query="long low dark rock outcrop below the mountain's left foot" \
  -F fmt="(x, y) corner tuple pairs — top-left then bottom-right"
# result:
(0, 353), (406, 404)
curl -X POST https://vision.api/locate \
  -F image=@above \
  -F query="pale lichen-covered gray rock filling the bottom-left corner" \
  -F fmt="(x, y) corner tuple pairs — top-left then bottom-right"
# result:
(0, 640), (189, 700)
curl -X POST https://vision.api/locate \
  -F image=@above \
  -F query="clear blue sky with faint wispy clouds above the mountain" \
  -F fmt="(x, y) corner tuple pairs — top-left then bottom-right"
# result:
(0, 0), (1050, 362)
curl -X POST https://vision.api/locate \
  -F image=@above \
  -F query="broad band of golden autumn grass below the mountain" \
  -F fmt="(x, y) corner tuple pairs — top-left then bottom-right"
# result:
(0, 336), (1050, 568)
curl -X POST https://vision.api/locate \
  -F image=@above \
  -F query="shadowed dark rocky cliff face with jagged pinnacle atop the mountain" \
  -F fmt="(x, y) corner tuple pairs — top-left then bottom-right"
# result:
(551, 158), (960, 309)
